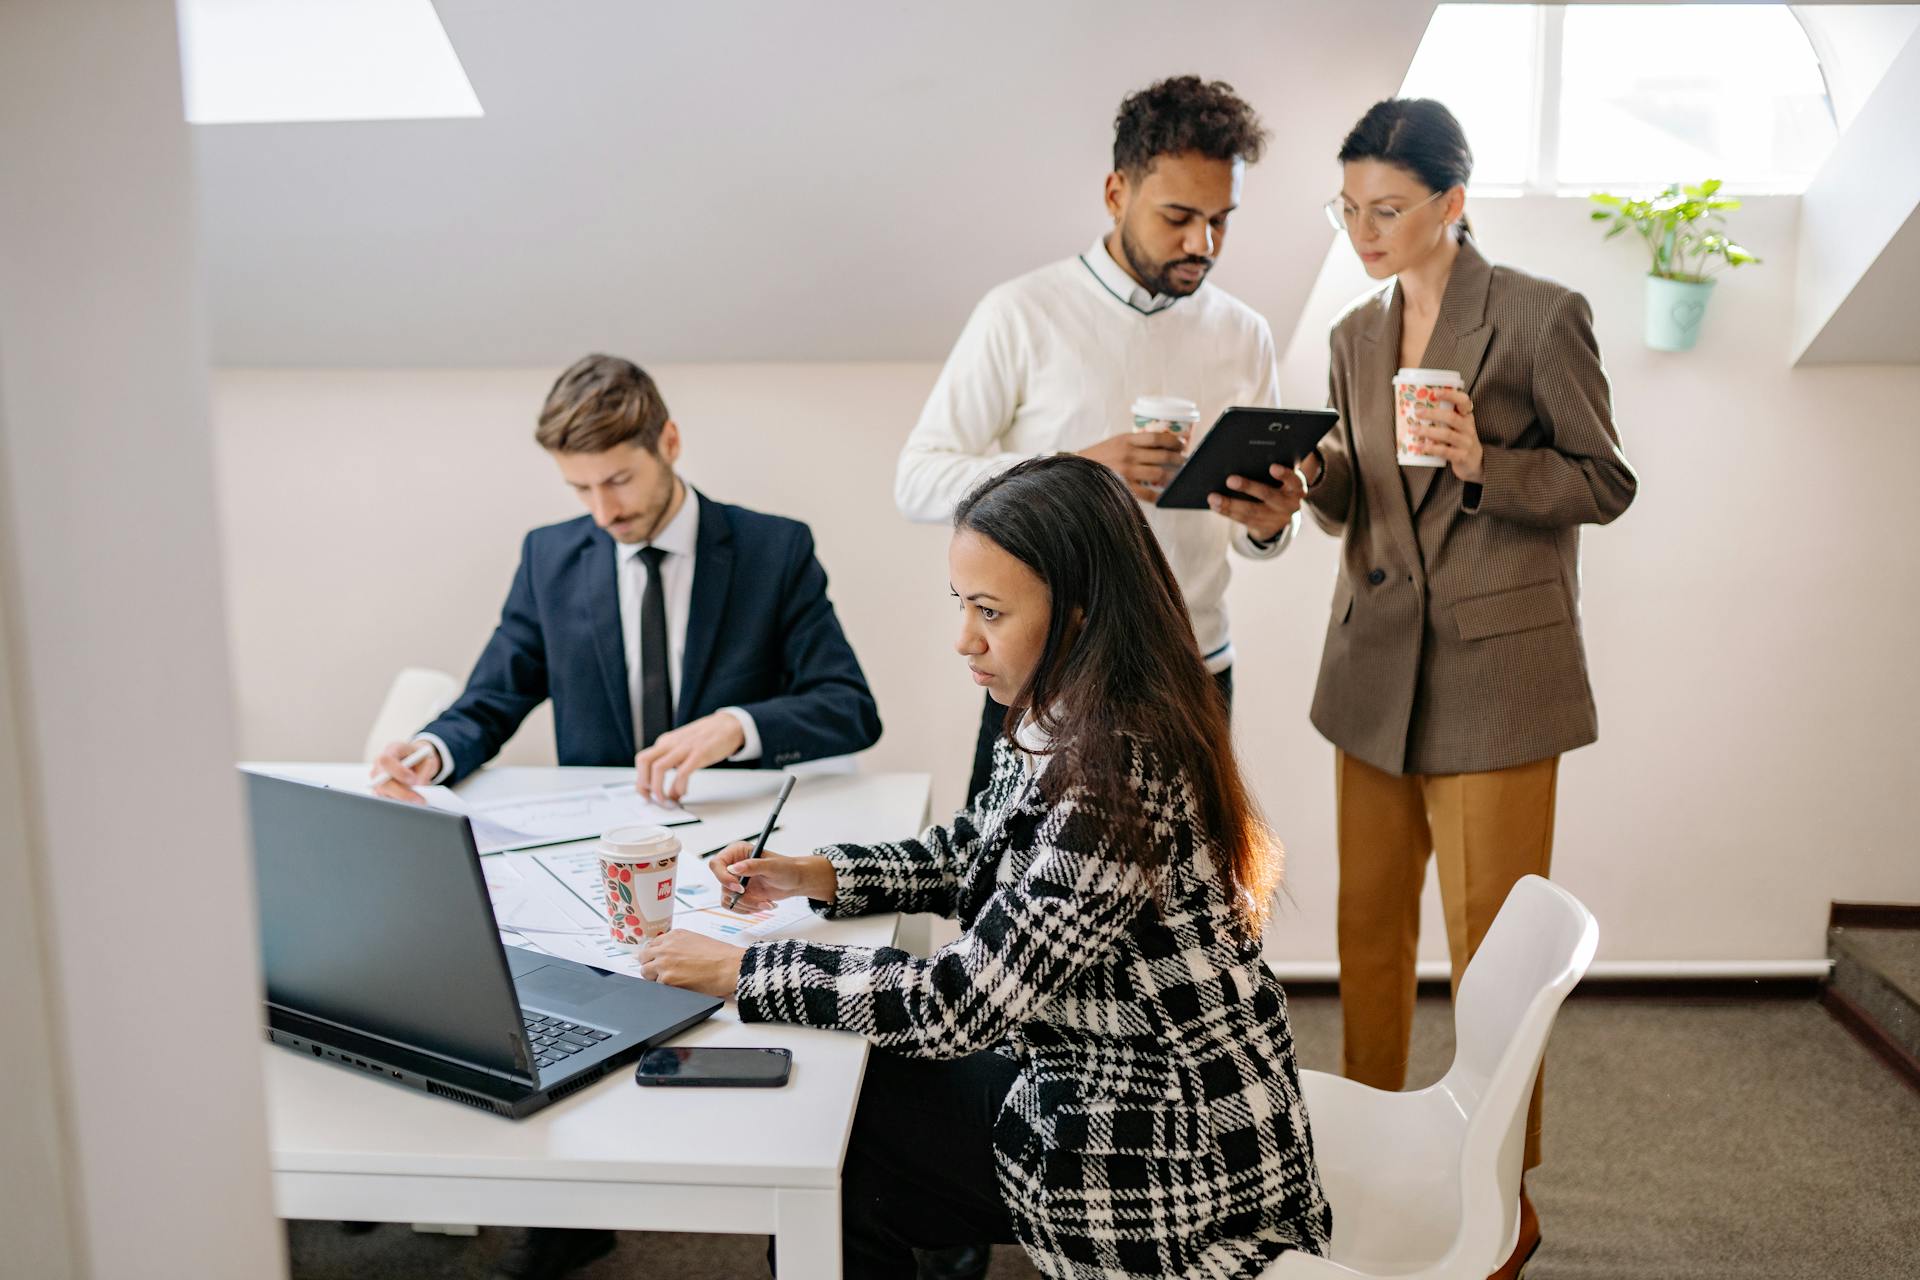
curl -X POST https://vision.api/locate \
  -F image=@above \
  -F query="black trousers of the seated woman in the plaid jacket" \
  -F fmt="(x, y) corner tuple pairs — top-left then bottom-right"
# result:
(766, 1048), (1020, 1280)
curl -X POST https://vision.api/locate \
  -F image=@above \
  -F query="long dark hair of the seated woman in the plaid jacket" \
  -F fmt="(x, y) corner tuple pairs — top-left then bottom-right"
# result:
(954, 453), (1281, 935)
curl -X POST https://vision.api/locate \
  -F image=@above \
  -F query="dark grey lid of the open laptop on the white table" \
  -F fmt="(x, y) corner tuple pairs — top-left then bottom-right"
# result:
(246, 773), (526, 1075)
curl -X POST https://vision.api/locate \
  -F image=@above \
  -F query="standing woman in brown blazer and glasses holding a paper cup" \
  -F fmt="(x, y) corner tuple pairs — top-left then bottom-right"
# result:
(1302, 98), (1636, 1276)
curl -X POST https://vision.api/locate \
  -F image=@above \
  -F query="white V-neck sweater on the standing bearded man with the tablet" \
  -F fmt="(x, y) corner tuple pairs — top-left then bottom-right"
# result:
(893, 240), (1300, 672)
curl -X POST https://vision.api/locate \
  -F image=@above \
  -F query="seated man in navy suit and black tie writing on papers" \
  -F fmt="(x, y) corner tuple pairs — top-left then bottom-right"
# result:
(374, 355), (879, 800)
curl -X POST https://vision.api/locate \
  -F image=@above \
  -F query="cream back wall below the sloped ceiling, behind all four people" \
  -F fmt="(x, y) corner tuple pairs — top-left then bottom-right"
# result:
(215, 200), (1920, 971)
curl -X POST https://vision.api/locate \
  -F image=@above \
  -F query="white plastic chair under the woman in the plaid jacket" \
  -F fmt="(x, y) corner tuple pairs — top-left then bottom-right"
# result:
(1263, 875), (1599, 1280)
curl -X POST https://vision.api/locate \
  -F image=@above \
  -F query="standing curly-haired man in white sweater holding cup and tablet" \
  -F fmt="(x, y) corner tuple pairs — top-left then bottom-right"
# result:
(893, 75), (1304, 794)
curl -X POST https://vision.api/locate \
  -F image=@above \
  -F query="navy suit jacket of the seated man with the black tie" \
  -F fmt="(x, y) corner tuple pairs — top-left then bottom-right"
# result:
(424, 491), (879, 783)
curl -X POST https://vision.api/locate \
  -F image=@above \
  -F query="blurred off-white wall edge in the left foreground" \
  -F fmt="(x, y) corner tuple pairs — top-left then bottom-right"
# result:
(0, 0), (284, 1280)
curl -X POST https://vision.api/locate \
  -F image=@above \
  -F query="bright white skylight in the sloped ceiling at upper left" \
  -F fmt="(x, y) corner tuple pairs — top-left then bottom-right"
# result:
(179, 0), (482, 125)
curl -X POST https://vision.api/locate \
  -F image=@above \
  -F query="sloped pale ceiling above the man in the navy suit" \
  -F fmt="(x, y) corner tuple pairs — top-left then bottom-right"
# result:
(194, 0), (1432, 367)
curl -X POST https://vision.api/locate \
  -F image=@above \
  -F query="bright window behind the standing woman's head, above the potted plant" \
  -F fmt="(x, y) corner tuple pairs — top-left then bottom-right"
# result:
(1400, 4), (1837, 194)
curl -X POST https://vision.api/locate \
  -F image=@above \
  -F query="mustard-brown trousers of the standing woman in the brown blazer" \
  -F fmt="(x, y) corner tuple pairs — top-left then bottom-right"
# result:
(1334, 750), (1559, 1169)
